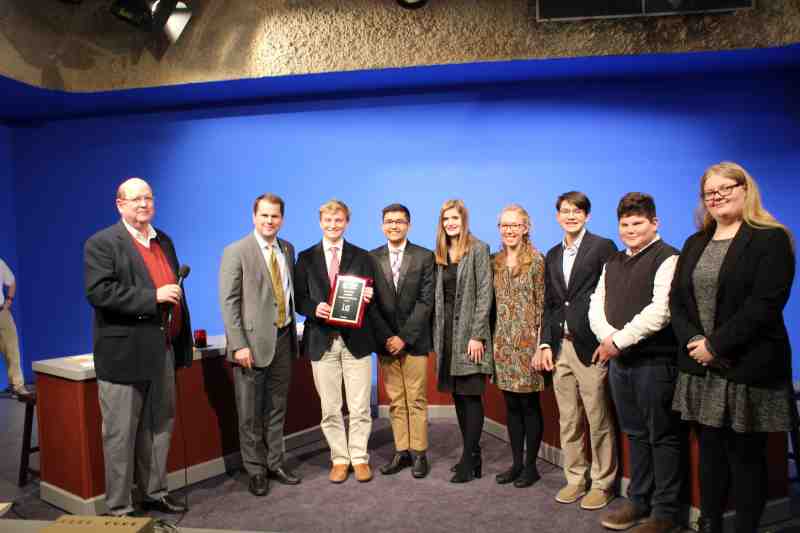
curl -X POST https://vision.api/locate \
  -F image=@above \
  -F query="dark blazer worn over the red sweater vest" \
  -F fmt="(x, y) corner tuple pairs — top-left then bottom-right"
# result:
(83, 221), (192, 383)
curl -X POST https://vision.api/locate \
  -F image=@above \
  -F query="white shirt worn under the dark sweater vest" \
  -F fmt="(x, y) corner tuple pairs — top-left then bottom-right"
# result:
(589, 235), (678, 350)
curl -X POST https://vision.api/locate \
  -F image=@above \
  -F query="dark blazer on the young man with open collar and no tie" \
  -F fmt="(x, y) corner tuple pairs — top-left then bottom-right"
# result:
(540, 231), (617, 366)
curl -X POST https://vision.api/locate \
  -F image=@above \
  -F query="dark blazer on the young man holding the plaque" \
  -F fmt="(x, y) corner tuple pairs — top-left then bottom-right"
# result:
(294, 241), (377, 361)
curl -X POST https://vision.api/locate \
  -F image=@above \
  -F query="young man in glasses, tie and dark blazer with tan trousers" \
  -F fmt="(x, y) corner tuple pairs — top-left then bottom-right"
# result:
(370, 204), (434, 478)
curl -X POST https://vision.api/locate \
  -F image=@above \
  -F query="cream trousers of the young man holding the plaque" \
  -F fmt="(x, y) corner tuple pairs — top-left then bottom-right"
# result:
(311, 337), (372, 465)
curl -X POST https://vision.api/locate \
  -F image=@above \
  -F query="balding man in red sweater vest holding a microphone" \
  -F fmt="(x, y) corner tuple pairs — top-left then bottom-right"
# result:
(84, 178), (192, 515)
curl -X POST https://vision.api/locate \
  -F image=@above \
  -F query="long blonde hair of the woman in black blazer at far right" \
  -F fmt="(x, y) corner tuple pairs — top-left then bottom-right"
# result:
(696, 161), (794, 242)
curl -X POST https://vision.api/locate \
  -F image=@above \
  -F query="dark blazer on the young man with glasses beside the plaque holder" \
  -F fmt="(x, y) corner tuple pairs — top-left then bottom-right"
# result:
(370, 242), (435, 355)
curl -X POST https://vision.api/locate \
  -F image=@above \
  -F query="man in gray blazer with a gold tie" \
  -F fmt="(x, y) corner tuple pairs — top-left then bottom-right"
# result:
(219, 194), (300, 496)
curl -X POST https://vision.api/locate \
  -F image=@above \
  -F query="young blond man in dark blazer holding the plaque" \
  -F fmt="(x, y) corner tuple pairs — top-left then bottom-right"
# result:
(294, 200), (376, 483)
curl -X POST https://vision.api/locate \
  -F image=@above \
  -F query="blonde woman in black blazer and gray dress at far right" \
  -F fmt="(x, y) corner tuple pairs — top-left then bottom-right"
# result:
(670, 162), (795, 533)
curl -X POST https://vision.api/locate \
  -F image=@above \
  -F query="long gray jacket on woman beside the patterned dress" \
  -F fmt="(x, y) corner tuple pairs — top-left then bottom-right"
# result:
(433, 237), (494, 376)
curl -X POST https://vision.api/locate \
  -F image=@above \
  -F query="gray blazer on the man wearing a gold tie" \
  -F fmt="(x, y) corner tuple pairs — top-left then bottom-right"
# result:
(219, 233), (299, 367)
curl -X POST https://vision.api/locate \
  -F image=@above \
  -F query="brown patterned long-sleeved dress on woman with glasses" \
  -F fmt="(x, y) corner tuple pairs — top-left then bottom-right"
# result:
(492, 247), (545, 393)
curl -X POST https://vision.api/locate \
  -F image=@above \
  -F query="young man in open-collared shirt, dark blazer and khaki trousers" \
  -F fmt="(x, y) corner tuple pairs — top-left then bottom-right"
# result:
(538, 191), (617, 509)
